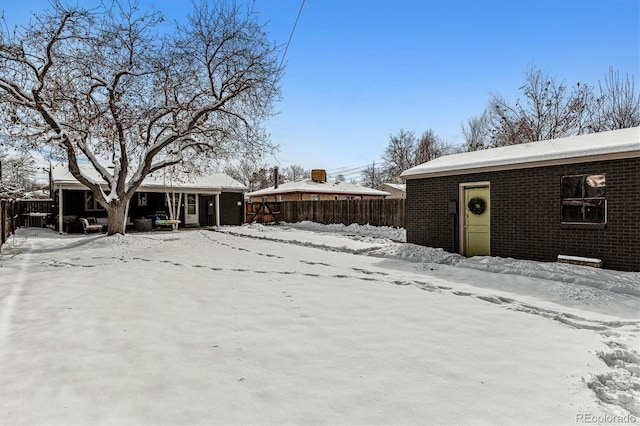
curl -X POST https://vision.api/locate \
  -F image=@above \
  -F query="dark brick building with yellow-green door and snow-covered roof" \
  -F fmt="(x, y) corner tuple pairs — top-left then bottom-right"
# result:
(402, 127), (640, 271)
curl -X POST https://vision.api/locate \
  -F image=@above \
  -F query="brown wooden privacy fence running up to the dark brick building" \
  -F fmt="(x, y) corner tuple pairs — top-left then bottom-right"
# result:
(254, 199), (404, 227)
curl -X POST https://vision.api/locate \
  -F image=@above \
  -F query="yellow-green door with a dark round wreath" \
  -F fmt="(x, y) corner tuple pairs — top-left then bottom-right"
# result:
(464, 187), (491, 256)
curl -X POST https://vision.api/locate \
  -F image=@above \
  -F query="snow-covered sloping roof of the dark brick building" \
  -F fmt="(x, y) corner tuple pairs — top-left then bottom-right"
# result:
(400, 127), (640, 179)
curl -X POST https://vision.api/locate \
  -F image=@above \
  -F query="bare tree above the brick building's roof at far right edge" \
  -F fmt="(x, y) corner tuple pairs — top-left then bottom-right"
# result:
(588, 68), (640, 132)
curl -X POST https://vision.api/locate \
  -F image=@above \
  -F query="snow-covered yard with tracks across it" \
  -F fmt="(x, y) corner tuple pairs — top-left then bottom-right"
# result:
(0, 222), (640, 424)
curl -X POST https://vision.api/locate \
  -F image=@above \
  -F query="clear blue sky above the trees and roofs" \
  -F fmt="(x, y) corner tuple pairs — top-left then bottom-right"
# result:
(0, 0), (640, 177)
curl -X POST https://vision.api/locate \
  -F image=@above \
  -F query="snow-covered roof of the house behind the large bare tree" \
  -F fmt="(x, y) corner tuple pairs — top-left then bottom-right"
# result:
(51, 163), (247, 194)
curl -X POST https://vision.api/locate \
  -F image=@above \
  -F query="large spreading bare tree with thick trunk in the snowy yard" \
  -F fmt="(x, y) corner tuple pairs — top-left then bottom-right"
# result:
(0, 0), (282, 234)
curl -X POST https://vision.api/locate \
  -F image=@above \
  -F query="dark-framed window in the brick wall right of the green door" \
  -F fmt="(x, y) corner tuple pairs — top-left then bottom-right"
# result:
(562, 174), (607, 223)
